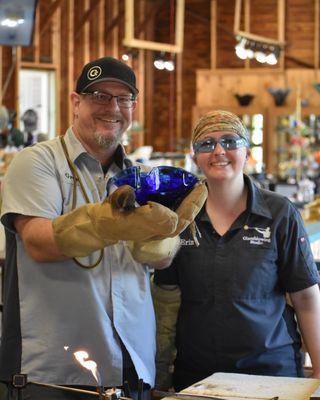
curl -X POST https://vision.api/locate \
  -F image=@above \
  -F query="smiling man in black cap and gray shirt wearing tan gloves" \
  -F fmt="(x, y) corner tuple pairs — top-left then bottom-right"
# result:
(0, 57), (206, 399)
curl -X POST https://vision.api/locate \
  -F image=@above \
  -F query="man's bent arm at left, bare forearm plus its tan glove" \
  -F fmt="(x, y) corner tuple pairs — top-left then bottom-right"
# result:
(14, 186), (178, 262)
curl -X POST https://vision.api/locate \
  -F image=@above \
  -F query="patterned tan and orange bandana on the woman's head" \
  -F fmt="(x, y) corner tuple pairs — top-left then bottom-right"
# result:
(192, 110), (249, 145)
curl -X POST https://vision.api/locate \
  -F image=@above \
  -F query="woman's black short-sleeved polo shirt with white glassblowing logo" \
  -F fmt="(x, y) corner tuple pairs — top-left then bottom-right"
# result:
(155, 176), (319, 390)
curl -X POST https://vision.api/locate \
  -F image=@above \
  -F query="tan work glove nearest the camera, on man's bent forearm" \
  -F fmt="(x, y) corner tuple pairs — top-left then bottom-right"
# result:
(52, 185), (178, 257)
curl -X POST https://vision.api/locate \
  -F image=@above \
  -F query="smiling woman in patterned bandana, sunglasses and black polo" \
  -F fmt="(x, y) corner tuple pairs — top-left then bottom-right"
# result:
(154, 111), (320, 391)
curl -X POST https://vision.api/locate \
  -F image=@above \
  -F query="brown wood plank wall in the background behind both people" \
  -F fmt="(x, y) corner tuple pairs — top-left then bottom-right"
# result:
(0, 0), (320, 151)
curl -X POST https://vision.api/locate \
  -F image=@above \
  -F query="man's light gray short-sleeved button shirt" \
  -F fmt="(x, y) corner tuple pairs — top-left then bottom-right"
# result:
(0, 128), (155, 386)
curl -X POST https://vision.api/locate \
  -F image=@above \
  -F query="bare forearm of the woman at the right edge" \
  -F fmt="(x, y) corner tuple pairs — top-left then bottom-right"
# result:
(290, 285), (320, 379)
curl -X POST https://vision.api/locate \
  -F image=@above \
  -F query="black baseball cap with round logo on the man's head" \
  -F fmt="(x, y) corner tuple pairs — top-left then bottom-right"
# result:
(76, 57), (139, 96)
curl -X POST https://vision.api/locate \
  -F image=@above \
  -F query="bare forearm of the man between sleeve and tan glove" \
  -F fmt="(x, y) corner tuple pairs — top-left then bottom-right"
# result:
(14, 215), (67, 262)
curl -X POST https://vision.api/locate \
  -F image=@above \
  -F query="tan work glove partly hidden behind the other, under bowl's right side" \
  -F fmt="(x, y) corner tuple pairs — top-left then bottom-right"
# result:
(129, 182), (208, 264)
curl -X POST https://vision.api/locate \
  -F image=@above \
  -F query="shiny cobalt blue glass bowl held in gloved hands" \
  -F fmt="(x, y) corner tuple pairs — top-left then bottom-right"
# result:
(112, 166), (199, 209)
